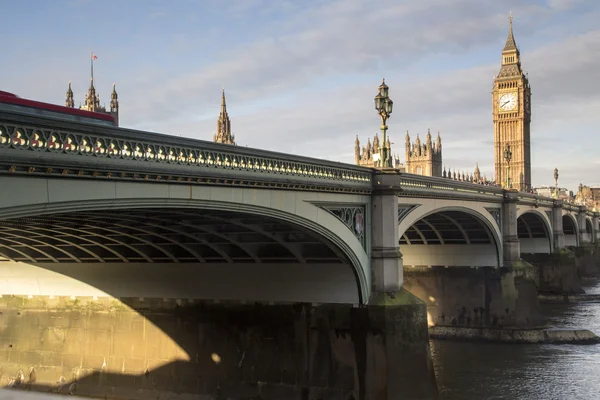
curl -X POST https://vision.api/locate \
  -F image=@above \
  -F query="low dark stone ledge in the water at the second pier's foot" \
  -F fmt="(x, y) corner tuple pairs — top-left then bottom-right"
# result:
(429, 325), (600, 344)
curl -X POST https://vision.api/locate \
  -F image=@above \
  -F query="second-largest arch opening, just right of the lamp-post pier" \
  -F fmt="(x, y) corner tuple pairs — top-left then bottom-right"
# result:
(398, 206), (502, 267)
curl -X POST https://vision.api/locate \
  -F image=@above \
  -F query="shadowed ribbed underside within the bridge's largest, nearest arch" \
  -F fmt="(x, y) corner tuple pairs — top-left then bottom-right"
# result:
(0, 208), (360, 303)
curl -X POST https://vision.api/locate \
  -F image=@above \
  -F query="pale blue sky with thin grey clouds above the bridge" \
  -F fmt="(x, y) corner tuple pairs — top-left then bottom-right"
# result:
(0, 0), (600, 190)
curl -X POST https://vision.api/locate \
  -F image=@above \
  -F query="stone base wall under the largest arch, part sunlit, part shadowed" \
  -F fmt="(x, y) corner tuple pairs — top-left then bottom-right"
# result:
(0, 292), (437, 400)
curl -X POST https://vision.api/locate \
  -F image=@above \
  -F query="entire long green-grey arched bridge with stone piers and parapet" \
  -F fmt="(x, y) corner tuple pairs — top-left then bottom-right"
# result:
(0, 111), (600, 400)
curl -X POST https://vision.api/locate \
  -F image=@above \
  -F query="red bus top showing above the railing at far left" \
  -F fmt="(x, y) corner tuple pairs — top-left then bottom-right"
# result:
(0, 90), (117, 126)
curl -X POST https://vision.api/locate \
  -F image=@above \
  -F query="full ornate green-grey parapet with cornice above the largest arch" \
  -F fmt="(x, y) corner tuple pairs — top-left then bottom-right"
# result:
(0, 112), (373, 193)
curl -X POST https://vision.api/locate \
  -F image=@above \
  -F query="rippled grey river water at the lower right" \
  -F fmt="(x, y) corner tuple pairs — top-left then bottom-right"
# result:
(431, 283), (600, 400)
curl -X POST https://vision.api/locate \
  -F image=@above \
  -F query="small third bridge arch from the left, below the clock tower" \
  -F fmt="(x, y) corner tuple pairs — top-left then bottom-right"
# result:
(517, 209), (554, 254)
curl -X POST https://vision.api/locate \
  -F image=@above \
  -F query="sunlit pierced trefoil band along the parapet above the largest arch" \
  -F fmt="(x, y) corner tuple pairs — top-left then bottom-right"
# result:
(0, 121), (372, 184)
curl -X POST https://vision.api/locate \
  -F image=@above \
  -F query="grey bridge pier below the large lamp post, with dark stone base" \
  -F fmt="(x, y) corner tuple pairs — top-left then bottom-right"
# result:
(340, 193), (438, 400)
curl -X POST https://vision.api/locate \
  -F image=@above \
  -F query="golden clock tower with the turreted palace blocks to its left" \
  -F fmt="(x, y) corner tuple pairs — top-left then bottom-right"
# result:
(354, 15), (531, 191)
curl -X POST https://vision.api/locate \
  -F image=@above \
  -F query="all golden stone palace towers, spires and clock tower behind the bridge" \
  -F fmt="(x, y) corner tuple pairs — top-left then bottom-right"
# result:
(65, 16), (600, 208)
